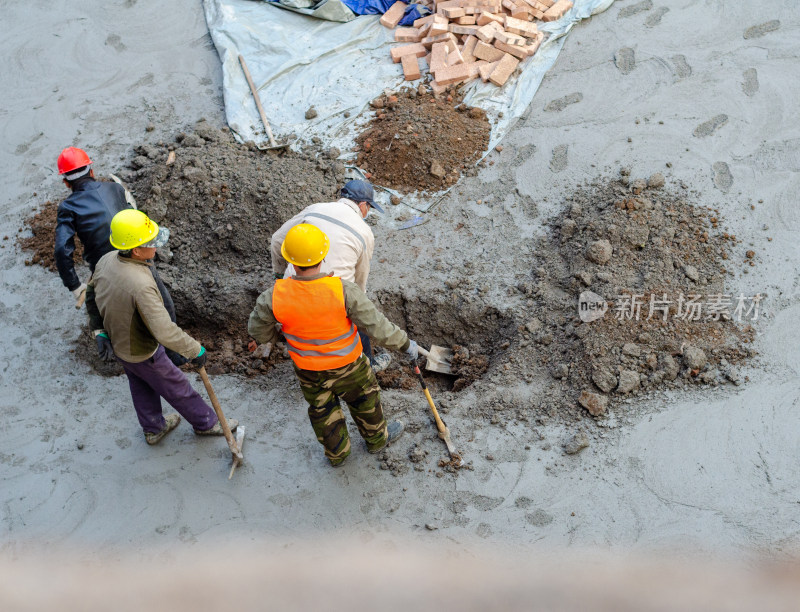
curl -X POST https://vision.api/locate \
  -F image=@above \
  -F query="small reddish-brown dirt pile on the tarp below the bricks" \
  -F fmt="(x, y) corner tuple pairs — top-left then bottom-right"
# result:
(356, 87), (491, 192)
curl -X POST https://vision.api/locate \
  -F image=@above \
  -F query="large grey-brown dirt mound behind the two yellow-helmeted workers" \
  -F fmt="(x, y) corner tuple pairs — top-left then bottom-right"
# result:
(20, 121), (345, 375)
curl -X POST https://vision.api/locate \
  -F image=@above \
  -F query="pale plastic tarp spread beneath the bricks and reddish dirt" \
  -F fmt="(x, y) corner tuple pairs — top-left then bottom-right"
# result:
(204, 0), (614, 210)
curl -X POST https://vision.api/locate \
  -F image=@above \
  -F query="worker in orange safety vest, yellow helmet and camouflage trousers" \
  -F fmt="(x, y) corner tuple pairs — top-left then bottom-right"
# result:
(247, 223), (419, 466)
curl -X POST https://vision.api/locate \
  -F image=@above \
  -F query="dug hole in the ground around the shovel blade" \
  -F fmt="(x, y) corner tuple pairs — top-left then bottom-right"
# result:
(375, 291), (517, 391)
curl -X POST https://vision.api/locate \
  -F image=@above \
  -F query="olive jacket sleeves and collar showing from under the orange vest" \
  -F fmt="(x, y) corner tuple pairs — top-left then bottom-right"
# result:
(247, 274), (411, 351)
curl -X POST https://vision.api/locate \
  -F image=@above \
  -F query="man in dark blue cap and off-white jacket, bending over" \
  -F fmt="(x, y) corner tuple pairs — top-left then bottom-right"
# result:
(271, 180), (392, 372)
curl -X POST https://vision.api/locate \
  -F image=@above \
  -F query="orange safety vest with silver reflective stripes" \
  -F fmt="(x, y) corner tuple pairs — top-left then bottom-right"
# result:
(272, 276), (362, 372)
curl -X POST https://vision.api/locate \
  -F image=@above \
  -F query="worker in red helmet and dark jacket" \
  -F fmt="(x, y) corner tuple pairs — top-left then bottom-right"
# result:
(55, 147), (186, 365)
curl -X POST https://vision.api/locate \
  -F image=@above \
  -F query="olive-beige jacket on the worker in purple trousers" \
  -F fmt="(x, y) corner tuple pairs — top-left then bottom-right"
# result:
(86, 251), (201, 363)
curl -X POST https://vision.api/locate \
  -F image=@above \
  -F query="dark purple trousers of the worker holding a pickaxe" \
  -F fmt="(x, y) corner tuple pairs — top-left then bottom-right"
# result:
(117, 346), (217, 433)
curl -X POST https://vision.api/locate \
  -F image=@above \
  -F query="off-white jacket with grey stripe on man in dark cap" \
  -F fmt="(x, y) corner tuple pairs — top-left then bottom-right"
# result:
(271, 198), (375, 291)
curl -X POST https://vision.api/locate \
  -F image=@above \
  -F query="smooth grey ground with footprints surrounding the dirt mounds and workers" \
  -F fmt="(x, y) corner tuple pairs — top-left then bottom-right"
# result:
(0, 0), (800, 568)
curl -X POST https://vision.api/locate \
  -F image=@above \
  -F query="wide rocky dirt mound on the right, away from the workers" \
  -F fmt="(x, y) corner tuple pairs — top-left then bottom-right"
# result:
(521, 169), (754, 415)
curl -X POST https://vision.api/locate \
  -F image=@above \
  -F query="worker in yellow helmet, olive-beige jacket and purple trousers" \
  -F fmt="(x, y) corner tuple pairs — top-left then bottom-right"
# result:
(86, 209), (238, 444)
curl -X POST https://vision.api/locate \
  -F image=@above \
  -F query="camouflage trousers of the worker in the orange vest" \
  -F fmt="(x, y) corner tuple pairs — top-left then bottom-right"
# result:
(294, 354), (386, 465)
